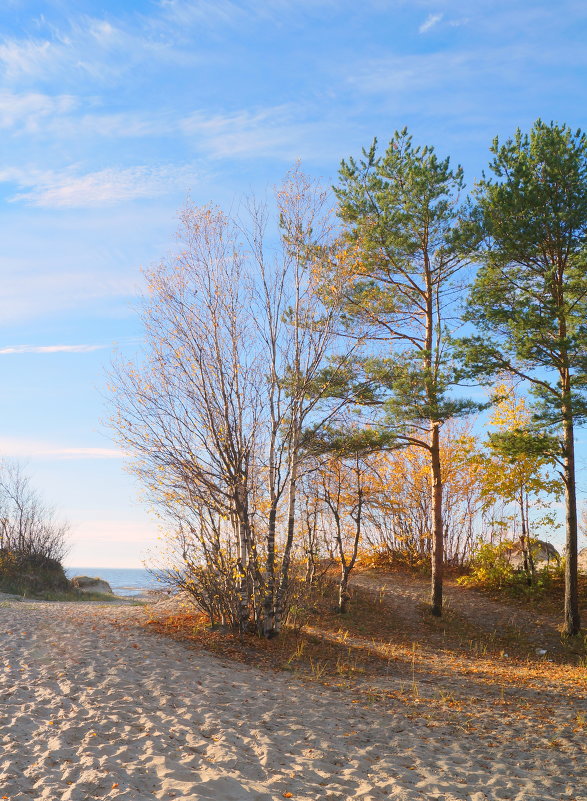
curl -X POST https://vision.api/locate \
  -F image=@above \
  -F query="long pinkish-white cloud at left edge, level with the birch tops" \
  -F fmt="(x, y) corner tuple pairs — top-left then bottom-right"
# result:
(0, 165), (196, 208)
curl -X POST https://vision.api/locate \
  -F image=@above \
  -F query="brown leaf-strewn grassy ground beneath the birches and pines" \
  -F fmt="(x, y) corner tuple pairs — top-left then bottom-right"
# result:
(148, 574), (587, 725)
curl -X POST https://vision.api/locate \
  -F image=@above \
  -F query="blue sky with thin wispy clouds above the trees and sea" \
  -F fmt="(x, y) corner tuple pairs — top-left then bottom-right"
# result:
(0, 0), (587, 567)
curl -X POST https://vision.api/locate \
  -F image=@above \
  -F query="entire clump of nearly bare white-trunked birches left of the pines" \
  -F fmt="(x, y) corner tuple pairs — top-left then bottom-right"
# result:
(112, 170), (346, 637)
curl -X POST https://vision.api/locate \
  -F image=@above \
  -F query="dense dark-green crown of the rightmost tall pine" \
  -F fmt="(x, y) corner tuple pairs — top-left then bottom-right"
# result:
(461, 120), (587, 425)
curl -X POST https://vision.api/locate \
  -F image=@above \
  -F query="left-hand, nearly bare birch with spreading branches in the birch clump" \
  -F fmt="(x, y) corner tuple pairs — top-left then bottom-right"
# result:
(113, 207), (262, 629)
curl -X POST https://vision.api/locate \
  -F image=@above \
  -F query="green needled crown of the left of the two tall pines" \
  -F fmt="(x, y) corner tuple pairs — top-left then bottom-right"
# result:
(335, 129), (479, 431)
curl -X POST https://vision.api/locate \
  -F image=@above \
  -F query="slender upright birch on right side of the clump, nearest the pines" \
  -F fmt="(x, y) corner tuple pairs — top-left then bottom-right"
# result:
(247, 168), (344, 636)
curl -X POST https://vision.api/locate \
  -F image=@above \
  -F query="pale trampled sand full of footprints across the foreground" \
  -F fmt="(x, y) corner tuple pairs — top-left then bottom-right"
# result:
(0, 601), (587, 801)
